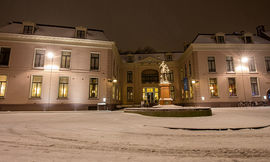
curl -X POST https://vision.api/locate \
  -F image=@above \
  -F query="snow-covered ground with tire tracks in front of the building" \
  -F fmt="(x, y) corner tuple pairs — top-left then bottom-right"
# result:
(0, 107), (270, 162)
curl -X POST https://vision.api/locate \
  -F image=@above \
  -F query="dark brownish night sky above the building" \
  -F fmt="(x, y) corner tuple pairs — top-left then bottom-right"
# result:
(0, 0), (270, 51)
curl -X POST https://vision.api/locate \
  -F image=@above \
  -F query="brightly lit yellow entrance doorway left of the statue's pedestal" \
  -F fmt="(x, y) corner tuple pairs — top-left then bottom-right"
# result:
(142, 87), (159, 106)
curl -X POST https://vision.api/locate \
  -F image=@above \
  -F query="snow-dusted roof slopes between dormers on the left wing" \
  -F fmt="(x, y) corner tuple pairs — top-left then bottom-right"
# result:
(0, 22), (108, 41)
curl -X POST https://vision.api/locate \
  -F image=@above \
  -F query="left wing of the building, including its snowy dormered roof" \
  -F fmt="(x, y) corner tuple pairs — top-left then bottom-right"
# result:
(0, 22), (121, 110)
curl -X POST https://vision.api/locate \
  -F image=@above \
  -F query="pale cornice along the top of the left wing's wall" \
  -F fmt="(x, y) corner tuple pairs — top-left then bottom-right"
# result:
(0, 33), (115, 49)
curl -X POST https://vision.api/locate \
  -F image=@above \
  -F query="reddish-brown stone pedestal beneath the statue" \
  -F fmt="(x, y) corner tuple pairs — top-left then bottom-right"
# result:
(159, 83), (172, 105)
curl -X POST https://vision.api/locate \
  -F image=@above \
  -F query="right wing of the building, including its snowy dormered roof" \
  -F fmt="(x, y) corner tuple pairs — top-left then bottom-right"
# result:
(178, 33), (270, 107)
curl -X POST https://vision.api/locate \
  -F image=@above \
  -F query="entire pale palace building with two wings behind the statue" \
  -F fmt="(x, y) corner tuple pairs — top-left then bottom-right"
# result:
(0, 22), (270, 111)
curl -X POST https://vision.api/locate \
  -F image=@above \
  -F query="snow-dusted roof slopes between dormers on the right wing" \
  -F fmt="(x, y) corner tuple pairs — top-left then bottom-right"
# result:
(192, 33), (270, 44)
